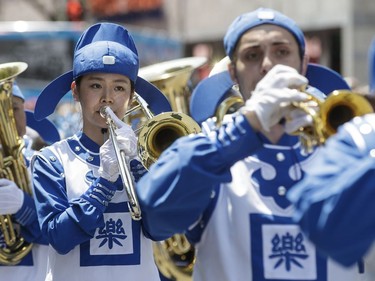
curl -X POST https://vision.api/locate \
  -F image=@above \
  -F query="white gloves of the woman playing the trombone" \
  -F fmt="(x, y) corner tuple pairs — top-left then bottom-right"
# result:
(99, 123), (137, 182)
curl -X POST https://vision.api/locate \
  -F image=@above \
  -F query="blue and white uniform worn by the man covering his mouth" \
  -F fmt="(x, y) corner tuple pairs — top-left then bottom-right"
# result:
(137, 114), (363, 281)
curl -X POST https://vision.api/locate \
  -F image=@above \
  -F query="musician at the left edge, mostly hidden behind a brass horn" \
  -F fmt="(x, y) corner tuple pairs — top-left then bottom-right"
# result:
(0, 82), (48, 281)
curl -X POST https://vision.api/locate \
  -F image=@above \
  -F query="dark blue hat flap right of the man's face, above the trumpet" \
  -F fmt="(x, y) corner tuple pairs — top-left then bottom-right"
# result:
(306, 63), (350, 95)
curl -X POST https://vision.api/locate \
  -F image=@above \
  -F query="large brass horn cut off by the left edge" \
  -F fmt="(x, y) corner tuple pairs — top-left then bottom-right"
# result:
(0, 62), (32, 265)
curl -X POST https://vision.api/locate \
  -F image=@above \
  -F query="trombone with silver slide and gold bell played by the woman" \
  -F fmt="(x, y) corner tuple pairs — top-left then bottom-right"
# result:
(100, 93), (201, 220)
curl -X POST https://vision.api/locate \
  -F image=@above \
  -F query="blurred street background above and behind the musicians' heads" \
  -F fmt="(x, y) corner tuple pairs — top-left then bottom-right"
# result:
(0, 0), (375, 137)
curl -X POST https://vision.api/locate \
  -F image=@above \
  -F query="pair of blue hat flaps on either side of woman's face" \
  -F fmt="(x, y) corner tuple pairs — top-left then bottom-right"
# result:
(34, 71), (172, 121)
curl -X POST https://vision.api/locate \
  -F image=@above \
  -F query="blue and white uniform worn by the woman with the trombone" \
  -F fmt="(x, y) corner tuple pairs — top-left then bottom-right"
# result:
(32, 133), (159, 281)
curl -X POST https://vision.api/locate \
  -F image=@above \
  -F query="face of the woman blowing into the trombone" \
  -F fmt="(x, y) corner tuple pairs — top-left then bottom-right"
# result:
(72, 73), (132, 132)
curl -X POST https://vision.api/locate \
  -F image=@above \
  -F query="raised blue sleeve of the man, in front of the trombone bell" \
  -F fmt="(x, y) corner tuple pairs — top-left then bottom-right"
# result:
(136, 112), (263, 240)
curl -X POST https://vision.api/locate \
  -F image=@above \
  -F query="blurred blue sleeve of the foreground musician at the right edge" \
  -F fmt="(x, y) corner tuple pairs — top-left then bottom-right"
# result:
(287, 116), (375, 266)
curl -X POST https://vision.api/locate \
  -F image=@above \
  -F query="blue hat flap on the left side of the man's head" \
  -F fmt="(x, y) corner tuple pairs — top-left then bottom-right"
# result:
(190, 71), (234, 124)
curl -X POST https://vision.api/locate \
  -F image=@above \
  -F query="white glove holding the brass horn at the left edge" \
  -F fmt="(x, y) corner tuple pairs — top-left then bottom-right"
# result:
(0, 179), (25, 215)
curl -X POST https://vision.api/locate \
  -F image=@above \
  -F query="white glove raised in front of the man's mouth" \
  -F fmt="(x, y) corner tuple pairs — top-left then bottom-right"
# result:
(245, 65), (308, 131)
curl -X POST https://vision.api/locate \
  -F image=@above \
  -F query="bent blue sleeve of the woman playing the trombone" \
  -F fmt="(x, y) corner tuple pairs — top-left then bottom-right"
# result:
(32, 149), (119, 254)
